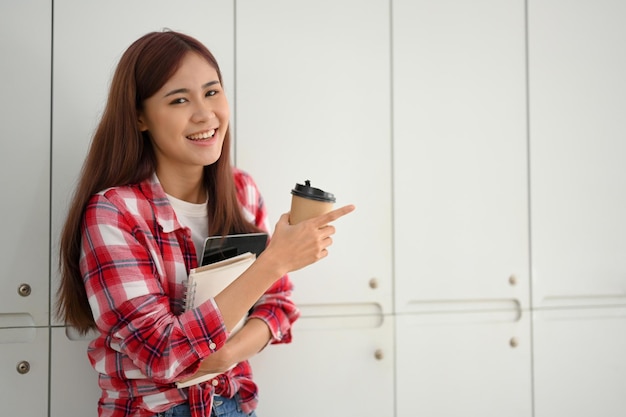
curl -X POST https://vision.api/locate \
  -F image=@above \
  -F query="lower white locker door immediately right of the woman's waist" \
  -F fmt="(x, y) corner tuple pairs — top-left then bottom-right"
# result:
(251, 316), (394, 417)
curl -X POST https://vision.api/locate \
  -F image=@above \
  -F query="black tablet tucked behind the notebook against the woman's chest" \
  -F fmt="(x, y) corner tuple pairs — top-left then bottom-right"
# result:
(200, 233), (268, 266)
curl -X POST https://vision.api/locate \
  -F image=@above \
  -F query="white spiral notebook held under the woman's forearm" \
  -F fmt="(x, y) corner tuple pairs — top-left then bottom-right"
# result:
(176, 252), (256, 388)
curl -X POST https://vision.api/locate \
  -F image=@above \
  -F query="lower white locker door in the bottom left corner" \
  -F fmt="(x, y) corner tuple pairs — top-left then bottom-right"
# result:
(0, 327), (49, 417)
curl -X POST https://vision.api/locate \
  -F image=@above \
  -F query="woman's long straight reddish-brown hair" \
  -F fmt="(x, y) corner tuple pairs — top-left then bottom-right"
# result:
(56, 31), (258, 333)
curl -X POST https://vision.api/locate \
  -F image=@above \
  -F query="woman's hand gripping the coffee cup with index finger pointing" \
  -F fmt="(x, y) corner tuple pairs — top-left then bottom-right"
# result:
(260, 204), (355, 276)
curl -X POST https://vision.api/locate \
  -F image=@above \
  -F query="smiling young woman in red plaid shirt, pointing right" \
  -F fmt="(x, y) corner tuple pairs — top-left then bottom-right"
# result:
(58, 31), (354, 417)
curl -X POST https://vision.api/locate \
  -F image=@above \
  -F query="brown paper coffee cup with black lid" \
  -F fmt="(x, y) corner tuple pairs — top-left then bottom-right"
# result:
(289, 180), (335, 224)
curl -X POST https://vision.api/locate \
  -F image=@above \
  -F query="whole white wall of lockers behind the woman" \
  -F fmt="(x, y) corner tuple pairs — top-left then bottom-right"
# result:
(0, 0), (626, 417)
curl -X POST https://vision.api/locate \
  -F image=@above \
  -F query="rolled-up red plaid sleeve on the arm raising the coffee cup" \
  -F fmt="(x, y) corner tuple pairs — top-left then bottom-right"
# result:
(80, 193), (227, 383)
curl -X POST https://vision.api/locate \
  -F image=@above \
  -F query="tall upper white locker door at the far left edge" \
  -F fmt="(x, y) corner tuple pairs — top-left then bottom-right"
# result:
(0, 0), (52, 328)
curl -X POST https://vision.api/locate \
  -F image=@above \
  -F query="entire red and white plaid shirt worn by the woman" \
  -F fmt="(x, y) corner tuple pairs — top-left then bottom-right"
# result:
(80, 170), (299, 417)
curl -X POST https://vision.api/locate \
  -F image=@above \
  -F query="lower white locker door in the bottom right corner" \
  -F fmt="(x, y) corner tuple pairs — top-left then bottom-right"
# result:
(533, 307), (626, 417)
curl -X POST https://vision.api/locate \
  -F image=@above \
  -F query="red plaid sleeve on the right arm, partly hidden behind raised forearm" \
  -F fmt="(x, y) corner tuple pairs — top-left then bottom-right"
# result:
(235, 170), (300, 343)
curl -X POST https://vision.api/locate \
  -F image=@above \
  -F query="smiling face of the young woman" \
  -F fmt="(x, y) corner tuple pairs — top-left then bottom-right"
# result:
(139, 52), (230, 180)
